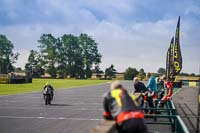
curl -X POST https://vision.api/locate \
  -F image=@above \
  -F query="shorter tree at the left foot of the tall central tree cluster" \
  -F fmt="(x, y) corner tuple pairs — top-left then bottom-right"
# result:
(25, 50), (44, 77)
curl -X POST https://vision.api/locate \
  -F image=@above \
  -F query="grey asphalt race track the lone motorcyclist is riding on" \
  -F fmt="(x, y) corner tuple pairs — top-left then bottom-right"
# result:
(0, 81), (170, 133)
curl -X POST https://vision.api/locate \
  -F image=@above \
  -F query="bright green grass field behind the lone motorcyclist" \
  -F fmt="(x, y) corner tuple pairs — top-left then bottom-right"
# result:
(0, 79), (108, 95)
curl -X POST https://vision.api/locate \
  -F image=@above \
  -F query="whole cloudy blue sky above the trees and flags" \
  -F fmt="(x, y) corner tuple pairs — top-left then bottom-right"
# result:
(0, 0), (200, 74)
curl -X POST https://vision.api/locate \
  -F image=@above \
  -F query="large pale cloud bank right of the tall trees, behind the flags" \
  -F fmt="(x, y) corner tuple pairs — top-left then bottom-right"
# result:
(85, 18), (200, 73)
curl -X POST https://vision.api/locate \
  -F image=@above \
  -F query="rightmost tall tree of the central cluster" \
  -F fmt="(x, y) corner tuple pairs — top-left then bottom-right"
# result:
(78, 34), (101, 78)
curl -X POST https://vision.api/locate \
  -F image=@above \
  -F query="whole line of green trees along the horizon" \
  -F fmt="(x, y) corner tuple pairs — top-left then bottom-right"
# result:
(0, 33), (198, 79)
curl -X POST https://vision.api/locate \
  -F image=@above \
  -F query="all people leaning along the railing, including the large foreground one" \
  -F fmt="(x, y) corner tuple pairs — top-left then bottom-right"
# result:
(103, 73), (172, 133)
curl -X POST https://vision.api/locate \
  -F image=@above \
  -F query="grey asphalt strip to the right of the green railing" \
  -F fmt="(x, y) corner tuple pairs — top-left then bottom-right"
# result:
(172, 86), (200, 133)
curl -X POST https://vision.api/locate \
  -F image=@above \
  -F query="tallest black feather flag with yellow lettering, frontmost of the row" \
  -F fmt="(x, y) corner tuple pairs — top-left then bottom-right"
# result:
(173, 16), (182, 76)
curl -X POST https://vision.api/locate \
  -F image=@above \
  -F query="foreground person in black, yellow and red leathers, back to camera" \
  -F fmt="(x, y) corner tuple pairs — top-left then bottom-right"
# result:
(103, 81), (147, 133)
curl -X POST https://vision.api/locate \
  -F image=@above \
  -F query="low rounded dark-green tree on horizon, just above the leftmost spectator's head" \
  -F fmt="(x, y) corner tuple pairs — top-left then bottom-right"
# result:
(124, 67), (139, 80)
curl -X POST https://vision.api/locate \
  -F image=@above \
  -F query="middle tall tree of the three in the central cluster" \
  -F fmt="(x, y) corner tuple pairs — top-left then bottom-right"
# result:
(58, 34), (84, 78)
